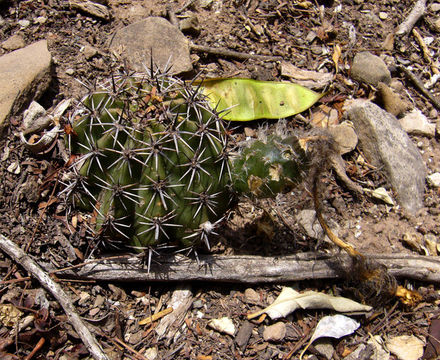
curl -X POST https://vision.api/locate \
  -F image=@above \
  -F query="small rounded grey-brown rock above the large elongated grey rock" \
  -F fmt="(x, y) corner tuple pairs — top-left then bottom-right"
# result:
(351, 51), (391, 86)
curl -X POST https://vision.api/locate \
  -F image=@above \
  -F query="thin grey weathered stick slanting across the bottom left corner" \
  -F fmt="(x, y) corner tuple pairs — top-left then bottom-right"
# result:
(0, 234), (109, 360)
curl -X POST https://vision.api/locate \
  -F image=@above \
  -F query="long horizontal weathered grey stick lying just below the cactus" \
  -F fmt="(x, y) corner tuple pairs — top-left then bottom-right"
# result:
(50, 253), (440, 283)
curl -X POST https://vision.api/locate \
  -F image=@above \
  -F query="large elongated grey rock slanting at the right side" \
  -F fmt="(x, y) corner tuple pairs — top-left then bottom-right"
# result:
(346, 100), (426, 214)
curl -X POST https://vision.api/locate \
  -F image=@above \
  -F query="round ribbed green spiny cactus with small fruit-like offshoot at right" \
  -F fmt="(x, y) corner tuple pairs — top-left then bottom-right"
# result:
(61, 72), (307, 250)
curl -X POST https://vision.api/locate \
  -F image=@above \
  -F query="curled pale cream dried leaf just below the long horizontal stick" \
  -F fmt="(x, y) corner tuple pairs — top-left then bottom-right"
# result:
(248, 287), (371, 319)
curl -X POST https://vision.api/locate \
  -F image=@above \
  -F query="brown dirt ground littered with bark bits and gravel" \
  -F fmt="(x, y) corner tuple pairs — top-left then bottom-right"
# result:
(0, 0), (440, 360)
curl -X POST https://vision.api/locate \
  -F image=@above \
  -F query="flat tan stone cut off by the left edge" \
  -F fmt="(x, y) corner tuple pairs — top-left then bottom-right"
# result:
(0, 40), (52, 134)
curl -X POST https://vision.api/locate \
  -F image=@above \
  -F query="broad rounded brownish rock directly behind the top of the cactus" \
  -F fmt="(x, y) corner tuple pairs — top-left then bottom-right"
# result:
(110, 17), (192, 74)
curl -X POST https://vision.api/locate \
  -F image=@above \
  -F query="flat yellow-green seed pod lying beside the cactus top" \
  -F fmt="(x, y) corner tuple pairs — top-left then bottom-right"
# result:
(199, 78), (322, 121)
